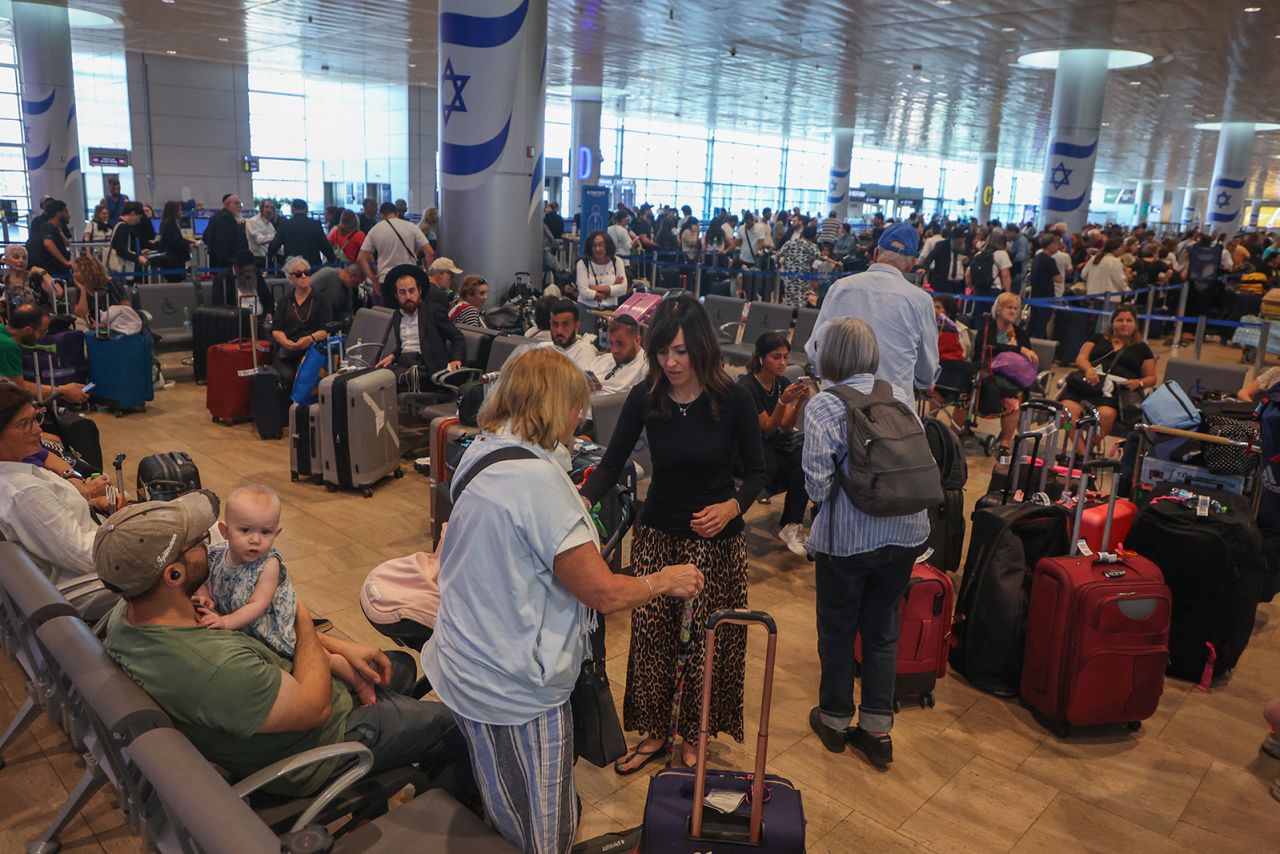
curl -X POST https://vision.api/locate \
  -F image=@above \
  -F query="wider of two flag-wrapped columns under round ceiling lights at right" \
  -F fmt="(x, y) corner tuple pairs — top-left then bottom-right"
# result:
(1041, 50), (1107, 232)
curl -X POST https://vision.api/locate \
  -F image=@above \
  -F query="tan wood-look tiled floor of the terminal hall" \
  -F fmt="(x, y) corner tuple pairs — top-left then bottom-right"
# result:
(0, 351), (1280, 853)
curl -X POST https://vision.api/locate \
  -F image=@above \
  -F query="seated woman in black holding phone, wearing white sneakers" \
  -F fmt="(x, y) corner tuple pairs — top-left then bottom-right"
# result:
(737, 332), (809, 557)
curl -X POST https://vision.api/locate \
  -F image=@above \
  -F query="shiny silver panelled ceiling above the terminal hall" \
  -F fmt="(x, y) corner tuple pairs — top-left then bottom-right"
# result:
(52, 0), (1280, 198)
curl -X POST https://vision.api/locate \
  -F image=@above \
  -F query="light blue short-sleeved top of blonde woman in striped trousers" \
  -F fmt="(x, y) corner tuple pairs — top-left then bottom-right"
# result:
(422, 434), (599, 726)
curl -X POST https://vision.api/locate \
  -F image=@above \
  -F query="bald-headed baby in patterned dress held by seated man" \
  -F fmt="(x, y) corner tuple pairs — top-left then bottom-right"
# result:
(193, 485), (376, 705)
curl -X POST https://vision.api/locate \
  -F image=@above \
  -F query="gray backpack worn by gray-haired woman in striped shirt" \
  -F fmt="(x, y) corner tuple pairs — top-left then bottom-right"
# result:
(828, 379), (943, 516)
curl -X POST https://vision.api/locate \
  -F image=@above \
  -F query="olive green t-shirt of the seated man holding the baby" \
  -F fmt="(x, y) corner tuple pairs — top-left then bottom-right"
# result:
(106, 602), (352, 796)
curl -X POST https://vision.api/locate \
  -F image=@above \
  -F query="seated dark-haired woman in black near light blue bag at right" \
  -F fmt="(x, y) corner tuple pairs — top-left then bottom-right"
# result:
(1060, 305), (1156, 453)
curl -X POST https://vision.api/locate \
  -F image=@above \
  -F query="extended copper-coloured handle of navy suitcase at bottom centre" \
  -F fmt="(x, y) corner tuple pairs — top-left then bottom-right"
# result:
(689, 608), (778, 845)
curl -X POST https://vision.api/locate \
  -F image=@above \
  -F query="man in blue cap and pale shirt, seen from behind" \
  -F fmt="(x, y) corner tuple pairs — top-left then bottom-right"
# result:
(805, 217), (938, 396)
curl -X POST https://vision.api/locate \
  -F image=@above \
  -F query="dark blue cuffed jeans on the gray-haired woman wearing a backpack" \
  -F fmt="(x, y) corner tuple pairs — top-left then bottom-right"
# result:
(814, 545), (920, 732)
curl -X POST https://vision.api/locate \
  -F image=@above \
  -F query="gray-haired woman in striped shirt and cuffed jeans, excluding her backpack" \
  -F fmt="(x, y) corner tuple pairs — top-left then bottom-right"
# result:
(804, 318), (929, 768)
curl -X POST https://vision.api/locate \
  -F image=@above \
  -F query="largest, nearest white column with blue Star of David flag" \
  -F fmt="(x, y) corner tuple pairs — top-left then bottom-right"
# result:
(439, 0), (547, 302)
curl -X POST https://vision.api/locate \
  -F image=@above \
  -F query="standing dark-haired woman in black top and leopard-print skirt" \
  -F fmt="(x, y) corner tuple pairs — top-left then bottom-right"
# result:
(582, 296), (764, 775)
